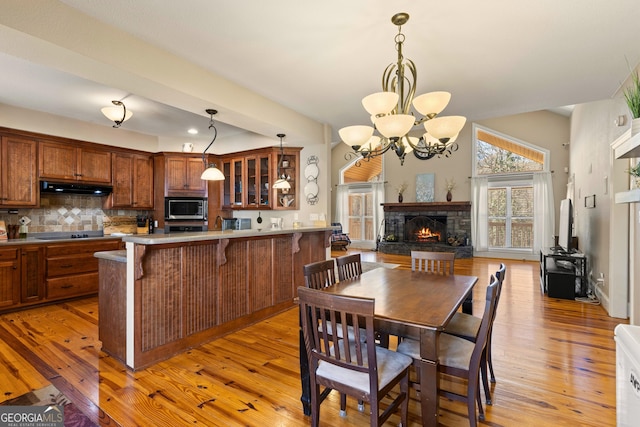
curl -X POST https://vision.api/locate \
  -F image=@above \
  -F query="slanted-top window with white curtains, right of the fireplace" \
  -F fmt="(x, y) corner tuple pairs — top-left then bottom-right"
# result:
(472, 124), (555, 254)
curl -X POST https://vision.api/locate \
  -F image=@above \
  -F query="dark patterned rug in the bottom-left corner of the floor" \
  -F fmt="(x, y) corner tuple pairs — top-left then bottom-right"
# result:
(0, 384), (97, 427)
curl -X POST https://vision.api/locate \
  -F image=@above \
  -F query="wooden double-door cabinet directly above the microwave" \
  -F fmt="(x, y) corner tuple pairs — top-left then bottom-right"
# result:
(154, 153), (207, 197)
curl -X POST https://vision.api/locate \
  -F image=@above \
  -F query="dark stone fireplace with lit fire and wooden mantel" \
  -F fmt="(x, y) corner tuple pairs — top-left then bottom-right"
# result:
(378, 202), (473, 258)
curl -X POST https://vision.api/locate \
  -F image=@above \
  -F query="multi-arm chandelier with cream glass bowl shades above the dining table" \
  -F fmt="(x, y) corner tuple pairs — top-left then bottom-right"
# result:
(338, 13), (466, 166)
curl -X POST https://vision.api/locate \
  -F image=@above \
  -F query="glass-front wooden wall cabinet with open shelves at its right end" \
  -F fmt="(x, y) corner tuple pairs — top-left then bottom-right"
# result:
(221, 147), (301, 210)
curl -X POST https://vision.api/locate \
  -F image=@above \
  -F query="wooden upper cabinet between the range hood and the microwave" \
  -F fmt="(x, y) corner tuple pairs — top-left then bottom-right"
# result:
(106, 153), (153, 210)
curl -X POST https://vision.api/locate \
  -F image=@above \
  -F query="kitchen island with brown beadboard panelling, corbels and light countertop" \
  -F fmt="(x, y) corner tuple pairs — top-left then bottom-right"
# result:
(95, 227), (333, 370)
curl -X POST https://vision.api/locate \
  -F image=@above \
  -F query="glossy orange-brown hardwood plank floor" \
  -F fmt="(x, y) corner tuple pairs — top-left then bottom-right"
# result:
(0, 251), (627, 426)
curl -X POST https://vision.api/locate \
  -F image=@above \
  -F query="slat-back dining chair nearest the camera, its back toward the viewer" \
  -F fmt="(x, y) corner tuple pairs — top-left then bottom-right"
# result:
(298, 287), (412, 427)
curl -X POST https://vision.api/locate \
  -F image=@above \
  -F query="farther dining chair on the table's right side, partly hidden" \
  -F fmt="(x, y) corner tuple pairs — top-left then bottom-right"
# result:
(444, 263), (507, 405)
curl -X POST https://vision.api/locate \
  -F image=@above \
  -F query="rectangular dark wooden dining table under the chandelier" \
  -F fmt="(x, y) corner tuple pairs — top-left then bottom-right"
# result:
(300, 268), (478, 426)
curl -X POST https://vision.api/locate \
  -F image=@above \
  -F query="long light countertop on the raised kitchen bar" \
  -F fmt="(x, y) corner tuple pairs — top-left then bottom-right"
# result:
(122, 226), (337, 245)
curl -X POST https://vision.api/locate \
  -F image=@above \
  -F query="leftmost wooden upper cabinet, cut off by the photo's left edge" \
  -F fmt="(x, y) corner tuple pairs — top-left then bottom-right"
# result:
(0, 136), (38, 208)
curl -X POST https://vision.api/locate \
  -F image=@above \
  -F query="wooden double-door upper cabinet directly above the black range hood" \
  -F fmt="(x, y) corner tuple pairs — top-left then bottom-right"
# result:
(39, 141), (111, 184)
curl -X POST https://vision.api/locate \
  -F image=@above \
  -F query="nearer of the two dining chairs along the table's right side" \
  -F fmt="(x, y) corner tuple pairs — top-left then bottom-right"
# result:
(397, 276), (501, 427)
